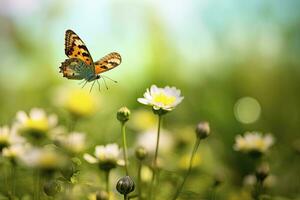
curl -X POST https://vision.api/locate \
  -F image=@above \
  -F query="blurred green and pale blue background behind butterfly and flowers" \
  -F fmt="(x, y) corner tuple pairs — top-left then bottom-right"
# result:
(0, 0), (300, 199)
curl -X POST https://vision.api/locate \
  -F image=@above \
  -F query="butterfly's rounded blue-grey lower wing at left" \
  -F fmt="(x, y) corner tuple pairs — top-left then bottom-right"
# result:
(59, 58), (91, 80)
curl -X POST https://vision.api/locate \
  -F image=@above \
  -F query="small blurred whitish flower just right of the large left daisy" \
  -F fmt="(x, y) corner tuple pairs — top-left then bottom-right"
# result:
(57, 132), (85, 154)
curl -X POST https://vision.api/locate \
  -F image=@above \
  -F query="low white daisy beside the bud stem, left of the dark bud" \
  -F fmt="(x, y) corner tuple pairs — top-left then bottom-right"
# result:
(83, 143), (124, 170)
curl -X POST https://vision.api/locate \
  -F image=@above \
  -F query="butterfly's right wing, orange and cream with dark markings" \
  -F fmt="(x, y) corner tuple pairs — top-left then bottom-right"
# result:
(94, 52), (122, 74)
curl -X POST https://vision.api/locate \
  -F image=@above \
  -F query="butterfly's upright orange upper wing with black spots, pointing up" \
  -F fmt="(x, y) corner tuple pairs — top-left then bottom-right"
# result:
(65, 30), (93, 65)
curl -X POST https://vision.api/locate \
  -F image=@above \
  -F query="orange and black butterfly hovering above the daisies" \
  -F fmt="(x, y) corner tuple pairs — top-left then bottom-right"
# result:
(59, 30), (122, 90)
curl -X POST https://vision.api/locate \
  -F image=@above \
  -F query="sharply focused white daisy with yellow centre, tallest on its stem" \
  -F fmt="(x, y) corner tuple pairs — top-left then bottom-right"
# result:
(138, 85), (184, 111)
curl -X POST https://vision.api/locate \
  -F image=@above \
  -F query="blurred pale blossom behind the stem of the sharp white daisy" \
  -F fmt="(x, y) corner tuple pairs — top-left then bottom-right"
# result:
(136, 128), (175, 153)
